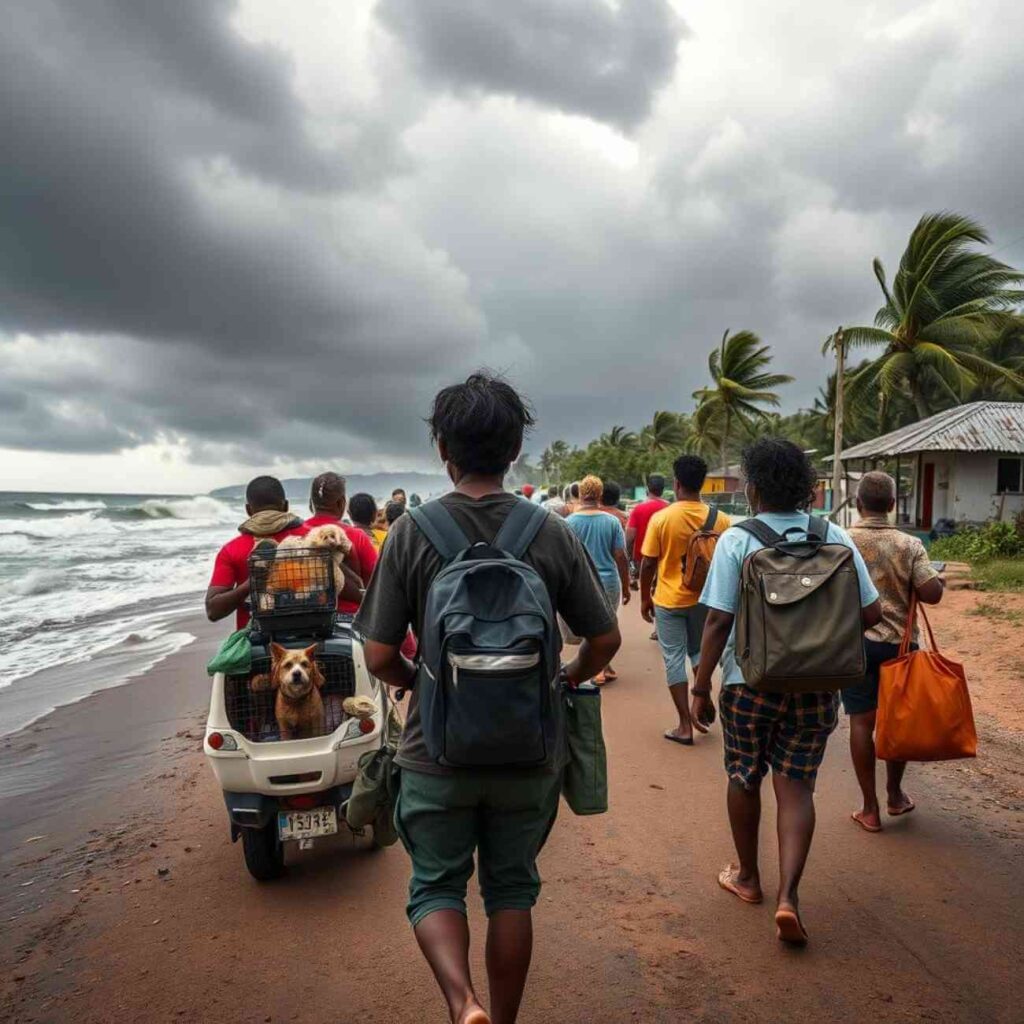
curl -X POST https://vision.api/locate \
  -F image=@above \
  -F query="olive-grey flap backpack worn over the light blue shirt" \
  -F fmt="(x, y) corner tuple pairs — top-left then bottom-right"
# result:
(736, 515), (866, 693)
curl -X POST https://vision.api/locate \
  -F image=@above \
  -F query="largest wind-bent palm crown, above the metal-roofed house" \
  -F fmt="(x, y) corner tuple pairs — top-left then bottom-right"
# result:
(845, 213), (1024, 419)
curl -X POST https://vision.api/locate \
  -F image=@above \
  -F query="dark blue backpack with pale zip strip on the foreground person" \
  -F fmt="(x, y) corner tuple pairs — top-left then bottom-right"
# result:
(409, 500), (564, 768)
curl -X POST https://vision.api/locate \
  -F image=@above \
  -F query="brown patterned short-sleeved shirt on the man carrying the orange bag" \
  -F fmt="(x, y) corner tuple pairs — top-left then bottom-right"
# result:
(850, 513), (938, 643)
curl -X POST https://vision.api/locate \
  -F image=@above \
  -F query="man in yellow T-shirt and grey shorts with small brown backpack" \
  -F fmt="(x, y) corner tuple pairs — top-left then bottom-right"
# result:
(640, 455), (731, 746)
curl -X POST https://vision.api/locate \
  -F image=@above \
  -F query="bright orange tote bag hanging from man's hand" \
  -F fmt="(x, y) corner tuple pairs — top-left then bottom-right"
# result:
(874, 596), (978, 761)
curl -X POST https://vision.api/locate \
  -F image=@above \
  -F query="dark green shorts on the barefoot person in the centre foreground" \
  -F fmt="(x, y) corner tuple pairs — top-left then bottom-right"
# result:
(395, 768), (561, 927)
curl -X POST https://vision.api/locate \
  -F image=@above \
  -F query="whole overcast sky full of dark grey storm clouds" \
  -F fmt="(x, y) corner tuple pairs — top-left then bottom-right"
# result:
(0, 0), (1024, 490)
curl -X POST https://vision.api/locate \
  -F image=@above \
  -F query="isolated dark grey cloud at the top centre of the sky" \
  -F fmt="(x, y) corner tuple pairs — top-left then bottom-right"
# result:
(377, 0), (684, 129)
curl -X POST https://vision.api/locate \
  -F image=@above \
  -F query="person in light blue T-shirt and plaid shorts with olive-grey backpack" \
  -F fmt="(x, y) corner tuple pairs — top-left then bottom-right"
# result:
(690, 438), (882, 945)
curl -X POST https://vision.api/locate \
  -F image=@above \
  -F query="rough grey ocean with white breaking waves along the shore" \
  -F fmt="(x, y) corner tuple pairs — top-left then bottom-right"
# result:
(0, 492), (245, 735)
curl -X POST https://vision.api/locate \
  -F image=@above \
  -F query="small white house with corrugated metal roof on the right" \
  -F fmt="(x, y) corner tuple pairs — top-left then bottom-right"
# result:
(828, 401), (1024, 529)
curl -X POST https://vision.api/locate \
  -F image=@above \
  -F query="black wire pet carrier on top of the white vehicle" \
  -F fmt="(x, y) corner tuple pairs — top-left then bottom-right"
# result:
(249, 545), (338, 639)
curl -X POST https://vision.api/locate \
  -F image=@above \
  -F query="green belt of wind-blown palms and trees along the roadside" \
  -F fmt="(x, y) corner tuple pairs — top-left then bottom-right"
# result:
(528, 212), (1024, 489)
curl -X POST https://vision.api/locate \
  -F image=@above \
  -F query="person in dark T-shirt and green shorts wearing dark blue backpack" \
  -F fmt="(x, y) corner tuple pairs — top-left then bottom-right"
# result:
(355, 374), (620, 1024)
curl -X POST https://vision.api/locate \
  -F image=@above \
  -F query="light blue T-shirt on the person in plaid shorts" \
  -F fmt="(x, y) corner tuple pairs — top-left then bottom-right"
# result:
(700, 512), (879, 686)
